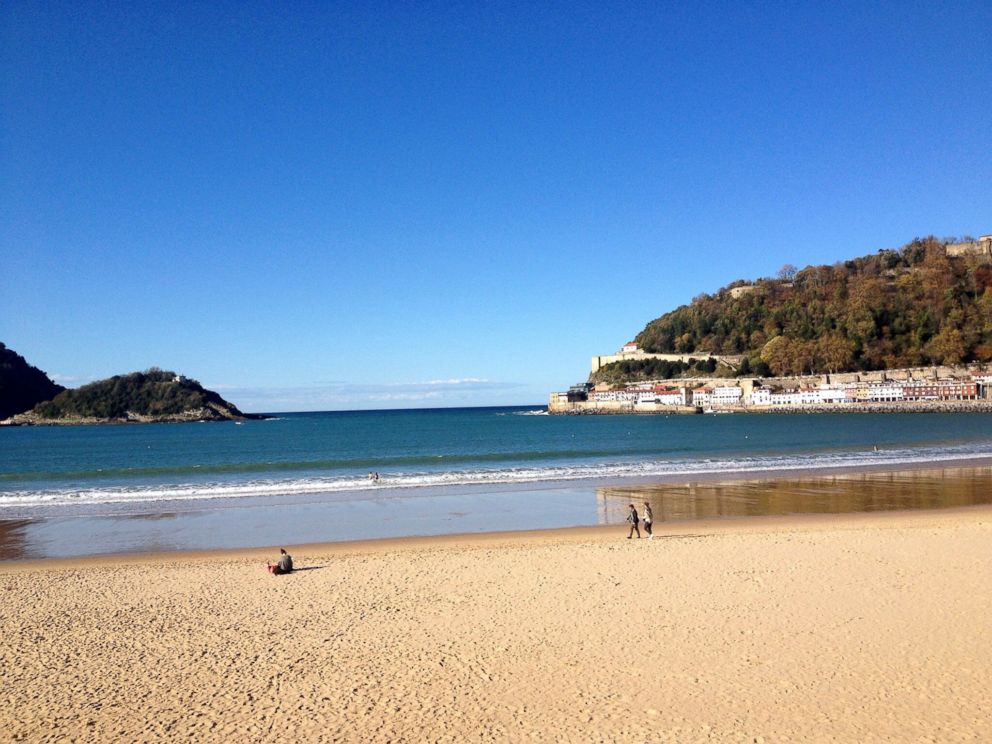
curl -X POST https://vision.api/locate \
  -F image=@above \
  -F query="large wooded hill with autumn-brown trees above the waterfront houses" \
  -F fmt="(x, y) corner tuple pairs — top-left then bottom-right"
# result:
(637, 238), (992, 375)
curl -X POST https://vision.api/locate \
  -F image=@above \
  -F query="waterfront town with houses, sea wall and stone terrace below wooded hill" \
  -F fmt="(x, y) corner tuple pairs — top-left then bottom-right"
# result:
(548, 342), (992, 414)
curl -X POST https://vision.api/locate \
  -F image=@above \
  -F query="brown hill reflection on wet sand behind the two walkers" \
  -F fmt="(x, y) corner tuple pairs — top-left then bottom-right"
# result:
(596, 467), (992, 524)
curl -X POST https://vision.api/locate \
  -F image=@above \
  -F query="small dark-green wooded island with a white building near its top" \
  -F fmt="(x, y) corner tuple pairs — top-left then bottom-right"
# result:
(17, 369), (252, 423)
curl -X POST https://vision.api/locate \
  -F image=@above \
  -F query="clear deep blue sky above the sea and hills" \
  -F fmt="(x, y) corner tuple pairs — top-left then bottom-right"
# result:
(0, 0), (992, 411)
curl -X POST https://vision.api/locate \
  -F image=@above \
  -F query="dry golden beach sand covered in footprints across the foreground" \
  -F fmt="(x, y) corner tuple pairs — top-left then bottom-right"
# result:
(0, 507), (992, 742)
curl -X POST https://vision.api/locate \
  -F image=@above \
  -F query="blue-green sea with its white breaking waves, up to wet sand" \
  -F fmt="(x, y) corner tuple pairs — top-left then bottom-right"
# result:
(0, 408), (992, 518)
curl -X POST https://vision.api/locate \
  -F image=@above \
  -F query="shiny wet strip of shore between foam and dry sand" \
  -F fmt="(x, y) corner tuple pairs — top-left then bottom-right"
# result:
(0, 465), (992, 560)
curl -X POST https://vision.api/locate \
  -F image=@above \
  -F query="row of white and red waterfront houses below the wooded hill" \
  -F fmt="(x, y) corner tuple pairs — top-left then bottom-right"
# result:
(568, 375), (992, 409)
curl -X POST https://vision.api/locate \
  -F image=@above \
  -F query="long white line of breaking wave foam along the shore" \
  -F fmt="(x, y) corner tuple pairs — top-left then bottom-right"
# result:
(0, 443), (992, 512)
